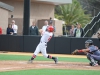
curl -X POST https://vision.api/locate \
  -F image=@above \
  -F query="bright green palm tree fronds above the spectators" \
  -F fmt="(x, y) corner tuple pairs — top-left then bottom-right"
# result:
(55, 0), (90, 26)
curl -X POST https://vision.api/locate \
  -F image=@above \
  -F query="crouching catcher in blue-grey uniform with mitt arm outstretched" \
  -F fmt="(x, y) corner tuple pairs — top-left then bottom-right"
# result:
(72, 40), (100, 66)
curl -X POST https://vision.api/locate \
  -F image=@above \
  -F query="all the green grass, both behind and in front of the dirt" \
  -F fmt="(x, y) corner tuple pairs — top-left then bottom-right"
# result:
(0, 54), (100, 75)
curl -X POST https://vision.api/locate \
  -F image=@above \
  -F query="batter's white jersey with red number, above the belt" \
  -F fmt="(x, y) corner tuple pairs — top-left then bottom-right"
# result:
(40, 31), (53, 43)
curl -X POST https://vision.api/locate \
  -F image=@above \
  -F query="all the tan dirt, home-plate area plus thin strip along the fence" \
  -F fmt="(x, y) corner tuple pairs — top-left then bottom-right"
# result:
(0, 52), (100, 72)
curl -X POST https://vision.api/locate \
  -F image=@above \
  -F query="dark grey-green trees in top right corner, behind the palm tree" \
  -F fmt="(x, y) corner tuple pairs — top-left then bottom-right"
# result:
(78, 0), (100, 17)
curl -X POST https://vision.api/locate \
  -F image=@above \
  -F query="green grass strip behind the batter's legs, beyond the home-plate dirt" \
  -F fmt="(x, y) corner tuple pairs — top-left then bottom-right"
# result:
(0, 54), (88, 62)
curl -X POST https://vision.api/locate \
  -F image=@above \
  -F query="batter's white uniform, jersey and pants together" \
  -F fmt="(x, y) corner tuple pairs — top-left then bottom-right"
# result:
(34, 31), (53, 58)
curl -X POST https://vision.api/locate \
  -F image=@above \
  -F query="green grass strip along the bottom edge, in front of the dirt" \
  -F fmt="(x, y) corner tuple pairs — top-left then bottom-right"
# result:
(0, 69), (100, 75)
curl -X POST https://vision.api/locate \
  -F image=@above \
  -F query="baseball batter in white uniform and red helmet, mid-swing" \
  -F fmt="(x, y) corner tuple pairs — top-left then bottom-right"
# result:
(29, 26), (58, 64)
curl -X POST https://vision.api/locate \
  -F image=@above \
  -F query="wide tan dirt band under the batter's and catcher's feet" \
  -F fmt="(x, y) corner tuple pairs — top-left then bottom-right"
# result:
(0, 61), (100, 72)
